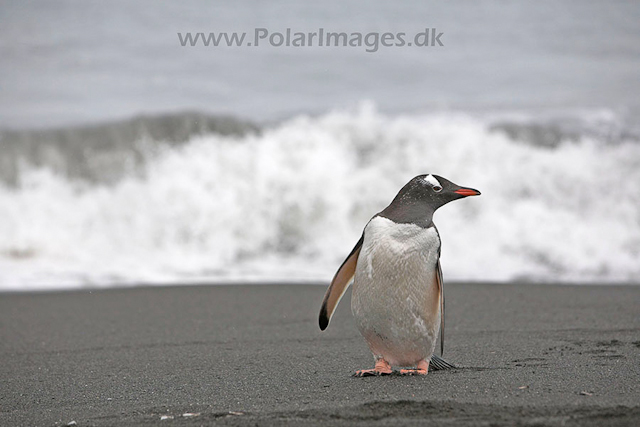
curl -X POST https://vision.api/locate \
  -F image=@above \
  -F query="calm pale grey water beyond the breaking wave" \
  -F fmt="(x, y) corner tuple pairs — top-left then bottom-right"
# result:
(0, 0), (640, 128)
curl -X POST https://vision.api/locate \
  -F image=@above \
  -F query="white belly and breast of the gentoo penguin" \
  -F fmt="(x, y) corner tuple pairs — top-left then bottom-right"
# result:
(351, 217), (440, 366)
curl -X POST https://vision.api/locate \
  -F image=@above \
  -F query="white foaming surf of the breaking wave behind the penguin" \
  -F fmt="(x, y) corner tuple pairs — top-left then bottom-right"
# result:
(0, 106), (640, 289)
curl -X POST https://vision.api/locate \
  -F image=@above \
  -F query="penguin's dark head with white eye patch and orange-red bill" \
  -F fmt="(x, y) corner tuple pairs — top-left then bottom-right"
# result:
(380, 174), (480, 227)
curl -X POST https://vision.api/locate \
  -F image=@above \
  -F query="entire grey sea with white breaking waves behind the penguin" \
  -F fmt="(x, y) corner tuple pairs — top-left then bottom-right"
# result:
(0, 0), (640, 290)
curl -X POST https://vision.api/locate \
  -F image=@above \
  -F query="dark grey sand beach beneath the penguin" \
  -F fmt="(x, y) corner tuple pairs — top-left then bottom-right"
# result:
(0, 284), (640, 426)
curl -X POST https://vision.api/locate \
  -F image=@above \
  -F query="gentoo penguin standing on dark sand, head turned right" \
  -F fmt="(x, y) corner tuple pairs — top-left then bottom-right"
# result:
(319, 174), (480, 376)
